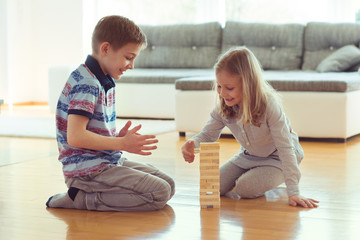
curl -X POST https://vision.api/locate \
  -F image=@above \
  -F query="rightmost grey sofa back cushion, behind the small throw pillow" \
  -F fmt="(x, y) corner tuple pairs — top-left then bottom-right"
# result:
(302, 22), (360, 70)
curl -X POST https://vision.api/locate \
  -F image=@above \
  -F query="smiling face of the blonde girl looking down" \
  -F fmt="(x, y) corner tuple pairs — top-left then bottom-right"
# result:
(216, 70), (242, 107)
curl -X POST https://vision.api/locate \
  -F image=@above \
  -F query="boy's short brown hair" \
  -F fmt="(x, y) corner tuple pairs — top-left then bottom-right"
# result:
(92, 15), (147, 53)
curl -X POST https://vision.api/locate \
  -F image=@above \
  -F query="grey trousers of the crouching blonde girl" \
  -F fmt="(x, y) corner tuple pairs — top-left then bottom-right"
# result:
(220, 161), (284, 198)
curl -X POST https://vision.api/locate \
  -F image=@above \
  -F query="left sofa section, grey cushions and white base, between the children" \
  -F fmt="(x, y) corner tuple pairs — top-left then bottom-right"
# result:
(116, 22), (222, 119)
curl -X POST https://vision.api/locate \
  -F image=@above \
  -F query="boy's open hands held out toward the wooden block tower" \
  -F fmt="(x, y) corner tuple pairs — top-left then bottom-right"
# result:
(118, 121), (158, 155)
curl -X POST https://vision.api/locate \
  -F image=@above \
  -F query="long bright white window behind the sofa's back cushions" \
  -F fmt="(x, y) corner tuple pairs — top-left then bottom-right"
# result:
(83, 0), (360, 56)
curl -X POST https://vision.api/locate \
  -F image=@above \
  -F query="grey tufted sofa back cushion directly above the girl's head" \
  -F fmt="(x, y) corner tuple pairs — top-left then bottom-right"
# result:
(222, 21), (304, 70)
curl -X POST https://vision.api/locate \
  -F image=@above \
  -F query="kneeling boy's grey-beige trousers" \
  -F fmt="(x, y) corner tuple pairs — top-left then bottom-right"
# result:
(65, 159), (175, 211)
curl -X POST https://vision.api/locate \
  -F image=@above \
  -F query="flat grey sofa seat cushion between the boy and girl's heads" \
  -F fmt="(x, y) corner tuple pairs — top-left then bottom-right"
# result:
(115, 68), (214, 84)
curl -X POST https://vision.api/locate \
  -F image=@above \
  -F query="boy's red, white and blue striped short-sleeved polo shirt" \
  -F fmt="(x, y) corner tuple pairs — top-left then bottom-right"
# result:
(56, 56), (121, 177)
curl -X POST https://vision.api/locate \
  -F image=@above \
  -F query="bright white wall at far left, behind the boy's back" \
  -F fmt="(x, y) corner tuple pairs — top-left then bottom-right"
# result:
(0, 0), (83, 104)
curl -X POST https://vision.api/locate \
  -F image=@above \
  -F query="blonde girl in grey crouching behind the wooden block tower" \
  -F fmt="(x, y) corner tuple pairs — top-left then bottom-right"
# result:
(182, 47), (318, 208)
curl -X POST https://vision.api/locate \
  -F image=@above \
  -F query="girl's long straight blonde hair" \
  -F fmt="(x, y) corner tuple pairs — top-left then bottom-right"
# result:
(214, 47), (280, 126)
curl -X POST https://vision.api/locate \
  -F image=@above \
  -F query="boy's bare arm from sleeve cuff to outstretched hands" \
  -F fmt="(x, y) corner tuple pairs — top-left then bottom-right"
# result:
(67, 114), (158, 155)
